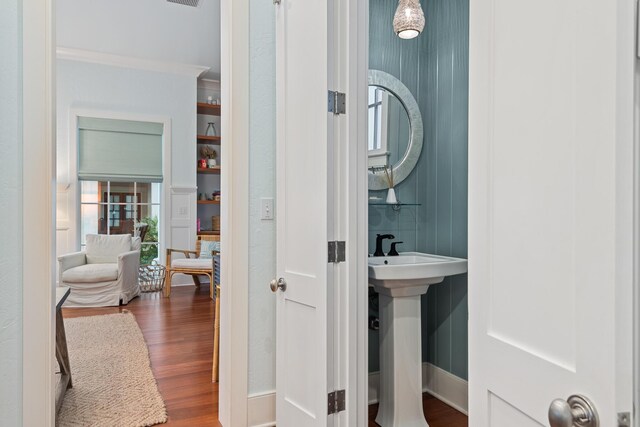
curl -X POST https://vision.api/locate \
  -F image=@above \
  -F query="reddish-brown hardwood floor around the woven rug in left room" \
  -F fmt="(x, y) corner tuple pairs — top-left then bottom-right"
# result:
(63, 286), (221, 427)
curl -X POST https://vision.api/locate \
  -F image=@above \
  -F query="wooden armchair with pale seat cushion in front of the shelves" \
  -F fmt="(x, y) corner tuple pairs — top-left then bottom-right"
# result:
(164, 236), (220, 299)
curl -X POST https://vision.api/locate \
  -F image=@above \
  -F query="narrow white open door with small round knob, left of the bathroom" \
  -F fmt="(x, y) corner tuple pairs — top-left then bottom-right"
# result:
(276, 0), (329, 427)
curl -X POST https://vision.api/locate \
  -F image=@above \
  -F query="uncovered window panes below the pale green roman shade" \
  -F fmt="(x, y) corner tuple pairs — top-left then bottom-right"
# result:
(80, 181), (162, 264)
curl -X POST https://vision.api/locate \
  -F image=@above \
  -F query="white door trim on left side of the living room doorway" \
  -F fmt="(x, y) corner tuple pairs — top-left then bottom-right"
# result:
(21, 0), (56, 426)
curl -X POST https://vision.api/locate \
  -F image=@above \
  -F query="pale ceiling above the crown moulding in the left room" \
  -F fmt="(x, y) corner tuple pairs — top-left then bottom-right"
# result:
(57, 0), (220, 79)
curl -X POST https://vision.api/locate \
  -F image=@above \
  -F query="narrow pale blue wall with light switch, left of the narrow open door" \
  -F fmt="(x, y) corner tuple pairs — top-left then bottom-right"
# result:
(249, 0), (278, 395)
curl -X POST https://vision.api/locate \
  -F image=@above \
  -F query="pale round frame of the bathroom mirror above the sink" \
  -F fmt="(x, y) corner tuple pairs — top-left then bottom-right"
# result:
(369, 70), (424, 190)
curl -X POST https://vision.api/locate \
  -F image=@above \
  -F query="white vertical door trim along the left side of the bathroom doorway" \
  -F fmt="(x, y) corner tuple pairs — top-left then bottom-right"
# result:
(340, 0), (369, 427)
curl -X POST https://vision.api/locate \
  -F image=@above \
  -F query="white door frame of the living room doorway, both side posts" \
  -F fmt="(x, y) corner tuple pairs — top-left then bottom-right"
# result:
(18, 0), (249, 426)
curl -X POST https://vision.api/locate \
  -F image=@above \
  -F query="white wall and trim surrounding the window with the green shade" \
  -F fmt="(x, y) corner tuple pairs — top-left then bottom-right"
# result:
(57, 60), (196, 260)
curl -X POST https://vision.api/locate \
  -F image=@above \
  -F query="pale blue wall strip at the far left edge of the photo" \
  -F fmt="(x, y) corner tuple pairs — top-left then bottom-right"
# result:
(0, 0), (22, 426)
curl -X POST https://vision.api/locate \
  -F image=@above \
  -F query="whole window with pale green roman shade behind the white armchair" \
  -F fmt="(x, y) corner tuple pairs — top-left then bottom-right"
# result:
(77, 116), (164, 264)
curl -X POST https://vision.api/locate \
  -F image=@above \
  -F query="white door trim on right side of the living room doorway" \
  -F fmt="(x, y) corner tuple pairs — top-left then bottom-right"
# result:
(219, 0), (250, 427)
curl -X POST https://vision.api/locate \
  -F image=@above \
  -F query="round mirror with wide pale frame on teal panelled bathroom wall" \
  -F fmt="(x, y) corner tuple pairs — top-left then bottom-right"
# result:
(368, 70), (423, 190)
